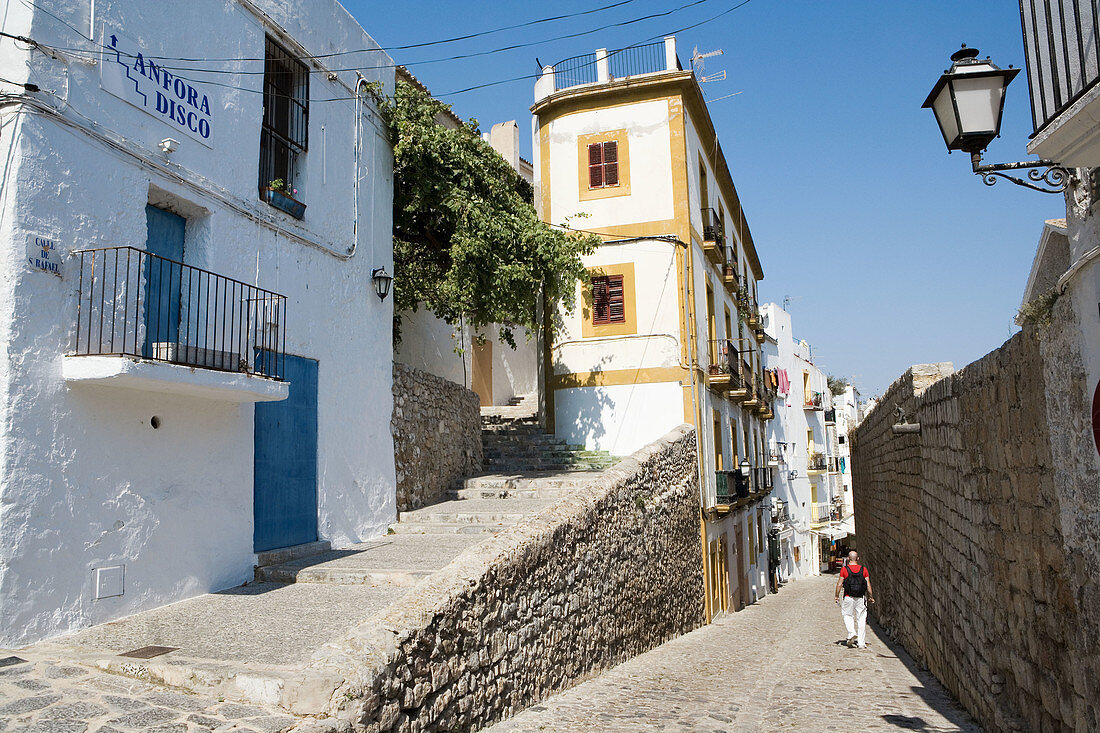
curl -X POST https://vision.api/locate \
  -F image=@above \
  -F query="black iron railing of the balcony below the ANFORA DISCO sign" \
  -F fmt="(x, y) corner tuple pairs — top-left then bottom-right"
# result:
(72, 247), (286, 380)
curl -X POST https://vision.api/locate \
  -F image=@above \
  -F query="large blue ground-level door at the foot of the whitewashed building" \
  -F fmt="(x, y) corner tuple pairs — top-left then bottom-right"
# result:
(253, 355), (317, 553)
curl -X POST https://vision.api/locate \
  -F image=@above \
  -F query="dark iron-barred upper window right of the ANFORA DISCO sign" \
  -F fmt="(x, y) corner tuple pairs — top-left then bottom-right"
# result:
(260, 36), (309, 195)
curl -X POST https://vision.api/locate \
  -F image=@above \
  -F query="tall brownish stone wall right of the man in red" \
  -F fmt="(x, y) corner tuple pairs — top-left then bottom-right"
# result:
(853, 330), (1100, 731)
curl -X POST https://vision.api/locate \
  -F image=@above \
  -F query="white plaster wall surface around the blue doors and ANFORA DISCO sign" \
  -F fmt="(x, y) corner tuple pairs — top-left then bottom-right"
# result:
(0, 0), (396, 646)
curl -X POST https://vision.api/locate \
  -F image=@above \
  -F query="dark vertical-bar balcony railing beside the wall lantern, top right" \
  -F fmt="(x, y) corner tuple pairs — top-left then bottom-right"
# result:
(1020, 0), (1100, 133)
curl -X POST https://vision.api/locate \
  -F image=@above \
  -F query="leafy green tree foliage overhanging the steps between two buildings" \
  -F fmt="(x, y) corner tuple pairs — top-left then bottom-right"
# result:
(383, 81), (600, 347)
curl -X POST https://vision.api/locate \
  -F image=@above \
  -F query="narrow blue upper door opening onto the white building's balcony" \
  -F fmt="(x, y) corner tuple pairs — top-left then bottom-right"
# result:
(142, 206), (187, 359)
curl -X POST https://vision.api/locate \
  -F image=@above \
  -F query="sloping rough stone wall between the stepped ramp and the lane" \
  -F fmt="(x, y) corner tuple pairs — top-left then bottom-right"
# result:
(323, 426), (704, 733)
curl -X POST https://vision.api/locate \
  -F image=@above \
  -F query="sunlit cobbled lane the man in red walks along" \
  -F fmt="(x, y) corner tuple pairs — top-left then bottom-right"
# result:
(488, 576), (981, 733)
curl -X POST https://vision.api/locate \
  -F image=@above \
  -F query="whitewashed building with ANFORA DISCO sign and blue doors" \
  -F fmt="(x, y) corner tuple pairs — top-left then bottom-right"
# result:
(0, 0), (396, 646)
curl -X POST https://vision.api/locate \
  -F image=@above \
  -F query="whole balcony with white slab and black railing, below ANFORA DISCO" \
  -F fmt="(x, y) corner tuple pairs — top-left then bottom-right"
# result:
(64, 247), (288, 402)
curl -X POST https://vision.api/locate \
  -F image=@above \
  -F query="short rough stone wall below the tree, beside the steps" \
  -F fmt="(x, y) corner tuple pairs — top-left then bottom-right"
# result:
(391, 362), (483, 512)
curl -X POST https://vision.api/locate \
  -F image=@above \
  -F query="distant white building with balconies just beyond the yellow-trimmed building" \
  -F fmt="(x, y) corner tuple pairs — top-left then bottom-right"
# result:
(760, 303), (851, 579)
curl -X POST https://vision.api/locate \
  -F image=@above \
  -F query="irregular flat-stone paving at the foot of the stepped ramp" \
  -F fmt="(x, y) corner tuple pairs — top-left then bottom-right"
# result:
(0, 652), (321, 733)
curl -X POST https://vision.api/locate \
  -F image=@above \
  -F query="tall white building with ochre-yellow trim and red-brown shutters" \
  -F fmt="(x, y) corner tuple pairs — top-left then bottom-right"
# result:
(531, 37), (773, 617)
